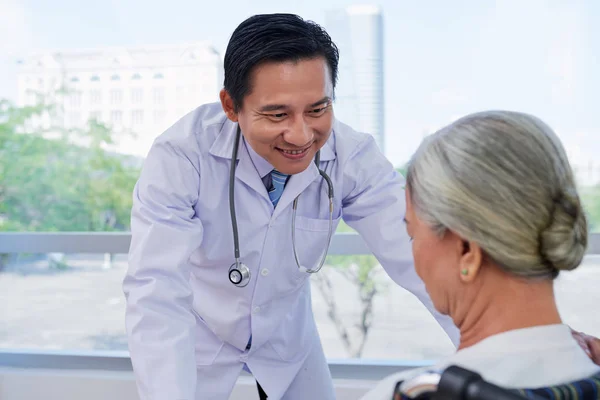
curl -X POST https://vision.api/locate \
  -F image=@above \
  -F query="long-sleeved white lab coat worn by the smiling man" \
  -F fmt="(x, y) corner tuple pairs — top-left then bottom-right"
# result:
(123, 103), (458, 400)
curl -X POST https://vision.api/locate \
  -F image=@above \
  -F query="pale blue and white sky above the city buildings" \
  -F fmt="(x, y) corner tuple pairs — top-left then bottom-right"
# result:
(0, 0), (600, 165)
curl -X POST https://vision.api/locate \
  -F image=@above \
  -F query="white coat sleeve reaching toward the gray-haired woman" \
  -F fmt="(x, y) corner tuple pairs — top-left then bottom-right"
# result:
(343, 136), (459, 346)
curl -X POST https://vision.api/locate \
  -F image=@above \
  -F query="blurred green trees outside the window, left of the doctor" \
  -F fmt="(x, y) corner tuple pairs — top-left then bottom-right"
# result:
(0, 96), (139, 231)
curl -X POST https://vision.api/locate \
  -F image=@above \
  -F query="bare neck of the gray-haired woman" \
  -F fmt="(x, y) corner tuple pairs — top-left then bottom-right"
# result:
(453, 271), (562, 350)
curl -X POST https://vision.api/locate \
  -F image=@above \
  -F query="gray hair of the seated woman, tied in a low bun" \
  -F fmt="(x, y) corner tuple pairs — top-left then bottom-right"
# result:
(406, 111), (587, 278)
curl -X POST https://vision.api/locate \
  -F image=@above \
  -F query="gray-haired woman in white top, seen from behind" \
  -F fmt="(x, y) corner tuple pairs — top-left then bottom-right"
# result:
(364, 111), (600, 400)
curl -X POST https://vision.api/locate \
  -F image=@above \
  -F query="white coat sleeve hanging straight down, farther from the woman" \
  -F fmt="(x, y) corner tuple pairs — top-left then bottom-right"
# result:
(123, 141), (203, 400)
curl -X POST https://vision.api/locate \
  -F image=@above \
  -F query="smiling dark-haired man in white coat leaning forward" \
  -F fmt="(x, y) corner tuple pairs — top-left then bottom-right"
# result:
(123, 14), (458, 400)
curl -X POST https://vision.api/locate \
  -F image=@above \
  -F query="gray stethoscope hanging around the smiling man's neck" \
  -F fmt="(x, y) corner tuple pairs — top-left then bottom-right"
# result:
(229, 125), (333, 287)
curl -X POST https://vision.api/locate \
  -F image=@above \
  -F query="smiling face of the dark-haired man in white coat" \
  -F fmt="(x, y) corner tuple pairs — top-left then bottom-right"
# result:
(221, 57), (333, 174)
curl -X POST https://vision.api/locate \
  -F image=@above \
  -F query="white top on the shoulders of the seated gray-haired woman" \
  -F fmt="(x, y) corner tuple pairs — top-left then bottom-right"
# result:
(361, 324), (600, 400)
